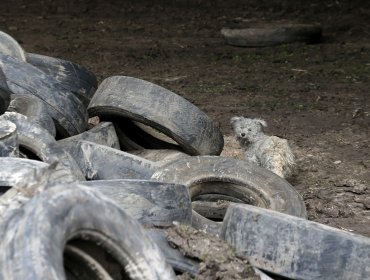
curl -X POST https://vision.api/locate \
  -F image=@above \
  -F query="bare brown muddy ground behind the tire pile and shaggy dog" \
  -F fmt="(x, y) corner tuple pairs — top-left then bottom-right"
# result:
(0, 0), (370, 237)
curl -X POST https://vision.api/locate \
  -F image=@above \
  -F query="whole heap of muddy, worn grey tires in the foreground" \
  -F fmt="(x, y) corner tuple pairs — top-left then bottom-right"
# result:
(0, 30), (370, 279)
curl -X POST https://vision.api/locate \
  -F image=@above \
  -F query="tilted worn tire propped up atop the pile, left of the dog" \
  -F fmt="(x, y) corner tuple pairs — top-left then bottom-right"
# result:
(88, 76), (224, 155)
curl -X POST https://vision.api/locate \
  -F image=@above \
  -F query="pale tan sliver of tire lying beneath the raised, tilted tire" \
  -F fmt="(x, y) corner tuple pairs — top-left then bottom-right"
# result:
(130, 149), (190, 165)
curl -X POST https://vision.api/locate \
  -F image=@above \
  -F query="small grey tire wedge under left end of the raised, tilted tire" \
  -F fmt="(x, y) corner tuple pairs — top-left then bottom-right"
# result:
(58, 122), (120, 150)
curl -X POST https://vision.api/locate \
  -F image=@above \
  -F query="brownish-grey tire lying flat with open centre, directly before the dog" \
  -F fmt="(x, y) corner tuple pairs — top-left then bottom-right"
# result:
(151, 156), (306, 235)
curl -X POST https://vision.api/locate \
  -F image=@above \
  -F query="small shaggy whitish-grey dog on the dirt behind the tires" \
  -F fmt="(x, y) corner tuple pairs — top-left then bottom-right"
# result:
(231, 117), (295, 178)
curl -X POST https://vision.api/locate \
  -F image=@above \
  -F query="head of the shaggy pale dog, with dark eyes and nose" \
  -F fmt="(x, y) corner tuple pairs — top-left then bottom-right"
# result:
(230, 117), (267, 143)
